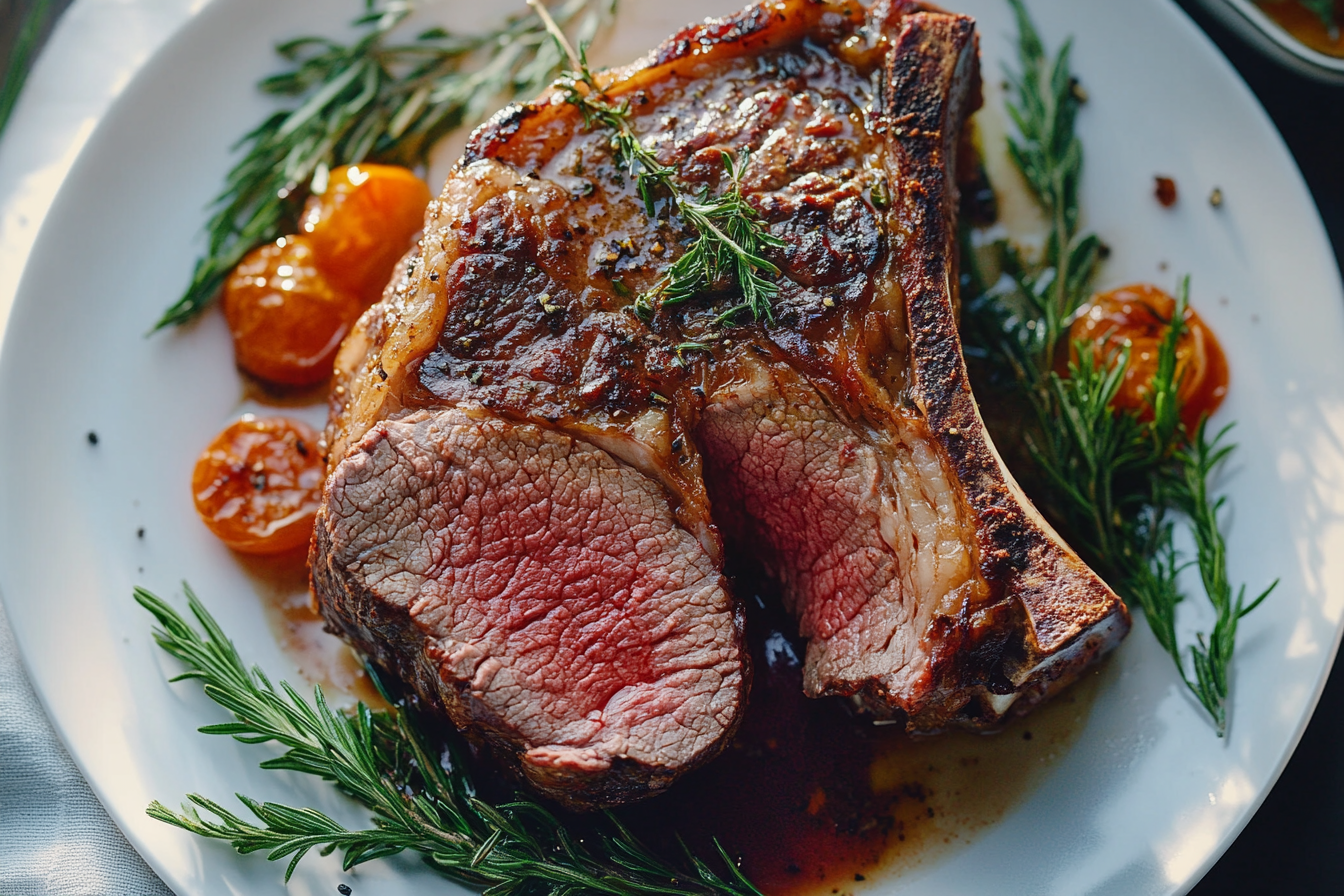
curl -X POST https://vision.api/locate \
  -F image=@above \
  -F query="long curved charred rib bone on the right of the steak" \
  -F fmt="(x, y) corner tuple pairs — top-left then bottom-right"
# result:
(884, 13), (1130, 709)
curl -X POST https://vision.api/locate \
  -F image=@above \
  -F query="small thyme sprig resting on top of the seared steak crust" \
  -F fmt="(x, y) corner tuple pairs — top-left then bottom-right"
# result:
(528, 0), (785, 324)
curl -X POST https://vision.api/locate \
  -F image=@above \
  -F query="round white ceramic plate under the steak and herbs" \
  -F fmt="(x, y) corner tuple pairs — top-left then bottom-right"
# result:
(0, 0), (1344, 896)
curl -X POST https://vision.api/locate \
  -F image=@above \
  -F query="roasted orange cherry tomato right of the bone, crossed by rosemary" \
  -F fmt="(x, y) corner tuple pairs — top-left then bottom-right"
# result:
(1068, 283), (1228, 433)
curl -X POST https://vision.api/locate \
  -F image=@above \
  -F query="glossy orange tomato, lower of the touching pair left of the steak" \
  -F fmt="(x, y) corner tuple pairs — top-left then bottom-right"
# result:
(223, 236), (363, 386)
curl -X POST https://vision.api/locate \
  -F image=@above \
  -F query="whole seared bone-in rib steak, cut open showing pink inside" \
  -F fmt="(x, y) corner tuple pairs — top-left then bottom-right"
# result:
(312, 0), (1129, 807)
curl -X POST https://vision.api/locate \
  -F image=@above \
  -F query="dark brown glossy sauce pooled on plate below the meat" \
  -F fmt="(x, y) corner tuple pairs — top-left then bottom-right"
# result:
(620, 578), (1099, 896)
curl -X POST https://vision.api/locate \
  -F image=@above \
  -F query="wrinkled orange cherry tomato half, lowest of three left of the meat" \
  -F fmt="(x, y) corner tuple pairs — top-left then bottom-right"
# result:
(191, 414), (325, 553)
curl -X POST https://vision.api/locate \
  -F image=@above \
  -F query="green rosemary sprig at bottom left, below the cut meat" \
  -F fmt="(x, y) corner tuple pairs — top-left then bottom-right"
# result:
(136, 588), (761, 896)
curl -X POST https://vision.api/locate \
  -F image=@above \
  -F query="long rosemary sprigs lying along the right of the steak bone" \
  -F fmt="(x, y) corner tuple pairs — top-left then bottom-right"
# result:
(964, 0), (1277, 736)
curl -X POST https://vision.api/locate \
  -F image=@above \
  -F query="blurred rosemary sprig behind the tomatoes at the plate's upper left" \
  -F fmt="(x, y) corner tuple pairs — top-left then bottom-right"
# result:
(155, 0), (616, 329)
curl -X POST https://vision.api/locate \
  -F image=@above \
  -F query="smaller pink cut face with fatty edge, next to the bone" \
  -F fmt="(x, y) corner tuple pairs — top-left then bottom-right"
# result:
(699, 365), (985, 696)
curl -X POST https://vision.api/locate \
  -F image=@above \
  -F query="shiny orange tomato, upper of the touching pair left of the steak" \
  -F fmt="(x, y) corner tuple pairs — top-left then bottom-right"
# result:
(300, 164), (430, 305)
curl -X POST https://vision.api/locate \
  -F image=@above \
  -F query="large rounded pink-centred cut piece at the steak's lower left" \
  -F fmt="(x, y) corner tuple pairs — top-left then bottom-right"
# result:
(313, 408), (742, 802)
